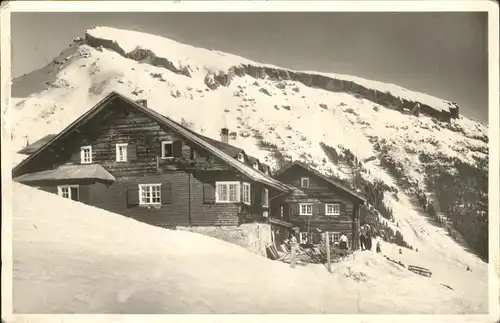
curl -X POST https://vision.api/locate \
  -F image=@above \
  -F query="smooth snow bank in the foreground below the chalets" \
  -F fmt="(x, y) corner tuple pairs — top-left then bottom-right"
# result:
(13, 184), (486, 314)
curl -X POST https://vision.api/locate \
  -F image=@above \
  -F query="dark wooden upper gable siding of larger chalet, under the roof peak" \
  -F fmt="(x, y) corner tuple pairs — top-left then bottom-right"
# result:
(15, 101), (228, 177)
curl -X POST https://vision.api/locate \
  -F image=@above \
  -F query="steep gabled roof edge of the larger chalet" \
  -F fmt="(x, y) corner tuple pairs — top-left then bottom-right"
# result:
(12, 92), (290, 192)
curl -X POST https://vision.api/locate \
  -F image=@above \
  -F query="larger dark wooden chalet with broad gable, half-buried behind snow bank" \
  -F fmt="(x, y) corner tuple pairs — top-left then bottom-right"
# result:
(12, 92), (292, 227)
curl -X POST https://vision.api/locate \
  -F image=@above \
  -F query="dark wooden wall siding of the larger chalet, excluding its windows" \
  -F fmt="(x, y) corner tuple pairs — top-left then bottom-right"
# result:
(13, 100), (282, 226)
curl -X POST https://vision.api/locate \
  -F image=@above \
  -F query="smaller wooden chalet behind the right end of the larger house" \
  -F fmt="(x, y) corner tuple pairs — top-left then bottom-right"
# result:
(270, 161), (365, 249)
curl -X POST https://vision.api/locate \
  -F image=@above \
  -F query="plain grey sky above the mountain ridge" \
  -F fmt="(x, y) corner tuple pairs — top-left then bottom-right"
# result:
(11, 12), (488, 122)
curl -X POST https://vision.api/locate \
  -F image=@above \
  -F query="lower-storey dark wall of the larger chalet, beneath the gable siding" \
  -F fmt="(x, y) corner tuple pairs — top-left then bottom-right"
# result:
(26, 171), (247, 226)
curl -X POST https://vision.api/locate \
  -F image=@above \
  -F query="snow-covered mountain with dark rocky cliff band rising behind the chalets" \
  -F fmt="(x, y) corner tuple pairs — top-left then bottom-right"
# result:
(13, 27), (488, 257)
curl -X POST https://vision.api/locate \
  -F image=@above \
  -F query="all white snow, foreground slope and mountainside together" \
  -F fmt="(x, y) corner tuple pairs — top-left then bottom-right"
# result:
(5, 28), (494, 313)
